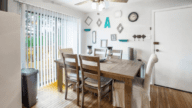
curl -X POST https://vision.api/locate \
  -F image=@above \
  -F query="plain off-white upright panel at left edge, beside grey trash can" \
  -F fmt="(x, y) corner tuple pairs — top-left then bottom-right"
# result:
(0, 11), (22, 108)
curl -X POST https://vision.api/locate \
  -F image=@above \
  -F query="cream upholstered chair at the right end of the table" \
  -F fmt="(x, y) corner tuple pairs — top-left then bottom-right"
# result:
(132, 54), (158, 108)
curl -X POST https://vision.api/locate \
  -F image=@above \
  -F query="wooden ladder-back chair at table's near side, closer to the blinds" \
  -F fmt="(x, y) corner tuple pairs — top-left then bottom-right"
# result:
(62, 53), (81, 105)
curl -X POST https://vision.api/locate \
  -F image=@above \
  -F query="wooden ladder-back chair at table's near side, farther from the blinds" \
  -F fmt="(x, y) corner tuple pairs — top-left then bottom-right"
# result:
(79, 55), (112, 108)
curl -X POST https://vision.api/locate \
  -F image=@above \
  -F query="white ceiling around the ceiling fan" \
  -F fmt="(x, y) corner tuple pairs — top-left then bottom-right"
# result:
(43, 0), (130, 13)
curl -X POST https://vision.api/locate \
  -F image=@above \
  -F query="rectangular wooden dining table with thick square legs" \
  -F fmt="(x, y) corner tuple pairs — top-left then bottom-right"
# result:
(55, 59), (142, 108)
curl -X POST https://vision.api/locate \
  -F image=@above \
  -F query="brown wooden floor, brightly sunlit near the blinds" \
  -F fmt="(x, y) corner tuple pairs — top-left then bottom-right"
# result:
(28, 84), (192, 108)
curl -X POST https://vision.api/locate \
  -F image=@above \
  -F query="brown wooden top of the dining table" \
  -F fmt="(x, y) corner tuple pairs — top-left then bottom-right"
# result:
(55, 59), (142, 79)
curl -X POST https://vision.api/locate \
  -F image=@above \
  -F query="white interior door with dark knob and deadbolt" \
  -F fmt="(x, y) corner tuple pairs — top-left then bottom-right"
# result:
(154, 8), (192, 92)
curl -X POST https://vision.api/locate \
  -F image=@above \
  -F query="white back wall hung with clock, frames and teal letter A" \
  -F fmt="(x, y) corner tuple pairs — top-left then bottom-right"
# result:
(84, 0), (192, 62)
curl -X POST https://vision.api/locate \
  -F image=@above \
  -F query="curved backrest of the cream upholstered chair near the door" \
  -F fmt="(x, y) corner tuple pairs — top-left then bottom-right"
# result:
(144, 54), (158, 93)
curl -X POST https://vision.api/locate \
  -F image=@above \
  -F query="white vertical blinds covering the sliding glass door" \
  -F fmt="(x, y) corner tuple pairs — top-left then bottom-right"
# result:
(24, 5), (79, 87)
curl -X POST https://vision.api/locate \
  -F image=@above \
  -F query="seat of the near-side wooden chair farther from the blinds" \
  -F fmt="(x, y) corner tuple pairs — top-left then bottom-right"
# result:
(85, 77), (112, 87)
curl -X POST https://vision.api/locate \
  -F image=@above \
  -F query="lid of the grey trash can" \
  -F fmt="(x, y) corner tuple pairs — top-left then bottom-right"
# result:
(21, 68), (38, 76)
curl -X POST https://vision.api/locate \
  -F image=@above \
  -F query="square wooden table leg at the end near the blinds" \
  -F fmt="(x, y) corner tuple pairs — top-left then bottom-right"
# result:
(56, 63), (63, 92)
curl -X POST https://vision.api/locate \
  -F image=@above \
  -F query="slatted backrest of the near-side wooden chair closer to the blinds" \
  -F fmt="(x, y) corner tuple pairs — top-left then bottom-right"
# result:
(62, 53), (79, 82)
